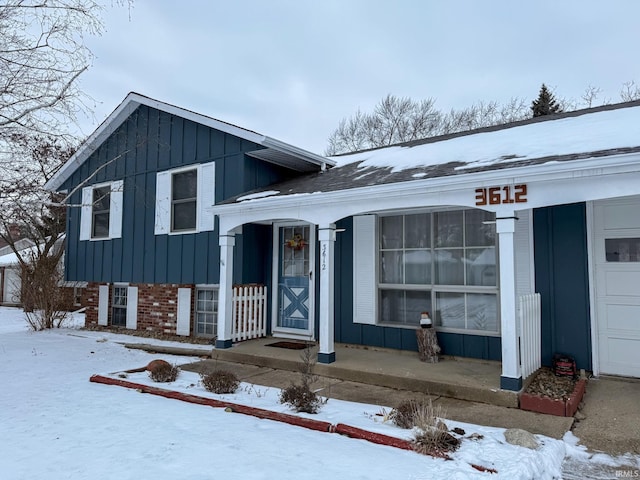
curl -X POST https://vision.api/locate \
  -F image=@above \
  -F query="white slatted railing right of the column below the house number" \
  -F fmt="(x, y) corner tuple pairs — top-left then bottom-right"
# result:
(518, 293), (542, 379)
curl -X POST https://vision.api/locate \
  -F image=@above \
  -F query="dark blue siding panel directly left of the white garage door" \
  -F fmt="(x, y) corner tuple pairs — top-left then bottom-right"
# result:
(533, 203), (592, 370)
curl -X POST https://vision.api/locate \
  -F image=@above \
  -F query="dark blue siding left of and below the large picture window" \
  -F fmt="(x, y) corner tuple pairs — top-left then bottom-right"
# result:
(334, 218), (501, 360)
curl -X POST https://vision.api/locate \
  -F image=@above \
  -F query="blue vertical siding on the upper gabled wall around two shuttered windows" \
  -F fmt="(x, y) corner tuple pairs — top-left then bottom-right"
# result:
(62, 106), (291, 284)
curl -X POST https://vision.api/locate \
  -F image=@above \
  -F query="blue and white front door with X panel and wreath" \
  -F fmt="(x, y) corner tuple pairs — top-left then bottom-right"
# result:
(273, 224), (315, 339)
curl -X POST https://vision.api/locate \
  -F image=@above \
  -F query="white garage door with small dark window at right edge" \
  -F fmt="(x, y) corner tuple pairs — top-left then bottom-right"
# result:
(593, 197), (640, 377)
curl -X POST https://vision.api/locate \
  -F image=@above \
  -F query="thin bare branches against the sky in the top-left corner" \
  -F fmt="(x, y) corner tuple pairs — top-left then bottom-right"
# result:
(0, 0), (102, 141)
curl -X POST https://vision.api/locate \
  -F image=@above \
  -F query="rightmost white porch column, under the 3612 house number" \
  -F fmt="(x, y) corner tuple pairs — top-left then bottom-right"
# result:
(496, 215), (522, 391)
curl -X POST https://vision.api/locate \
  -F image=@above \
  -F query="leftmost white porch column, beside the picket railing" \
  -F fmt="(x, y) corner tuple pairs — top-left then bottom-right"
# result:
(216, 232), (236, 348)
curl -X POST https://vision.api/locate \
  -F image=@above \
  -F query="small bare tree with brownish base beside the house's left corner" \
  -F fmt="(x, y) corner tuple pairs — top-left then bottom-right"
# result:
(0, 134), (74, 330)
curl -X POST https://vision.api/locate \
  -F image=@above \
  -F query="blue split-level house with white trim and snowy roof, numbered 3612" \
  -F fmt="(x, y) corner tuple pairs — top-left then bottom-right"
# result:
(48, 94), (640, 390)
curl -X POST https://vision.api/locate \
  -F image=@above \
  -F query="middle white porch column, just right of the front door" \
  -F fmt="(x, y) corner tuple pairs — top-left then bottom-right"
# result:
(318, 224), (336, 363)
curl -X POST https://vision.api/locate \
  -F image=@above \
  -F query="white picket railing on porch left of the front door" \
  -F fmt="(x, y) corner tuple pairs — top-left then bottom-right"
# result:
(231, 285), (267, 342)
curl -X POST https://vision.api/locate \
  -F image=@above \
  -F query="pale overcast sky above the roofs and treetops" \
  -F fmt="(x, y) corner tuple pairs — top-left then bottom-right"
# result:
(82, 0), (640, 153)
